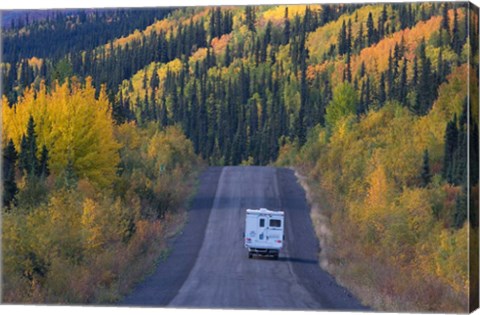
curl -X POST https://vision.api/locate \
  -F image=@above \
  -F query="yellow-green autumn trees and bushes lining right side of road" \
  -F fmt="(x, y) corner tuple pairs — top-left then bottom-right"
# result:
(277, 37), (478, 312)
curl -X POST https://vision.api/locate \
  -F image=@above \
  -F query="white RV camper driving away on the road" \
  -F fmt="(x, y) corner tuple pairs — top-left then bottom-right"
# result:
(245, 208), (285, 259)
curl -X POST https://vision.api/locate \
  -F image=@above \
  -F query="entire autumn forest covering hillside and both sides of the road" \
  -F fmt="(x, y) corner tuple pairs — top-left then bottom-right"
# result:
(0, 2), (479, 311)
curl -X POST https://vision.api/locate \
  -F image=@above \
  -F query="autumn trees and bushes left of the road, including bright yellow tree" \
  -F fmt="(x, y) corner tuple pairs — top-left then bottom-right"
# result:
(2, 79), (201, 303)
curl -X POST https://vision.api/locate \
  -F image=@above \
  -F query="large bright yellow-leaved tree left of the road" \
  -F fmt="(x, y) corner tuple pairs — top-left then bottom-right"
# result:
(2, 78), (120, 188)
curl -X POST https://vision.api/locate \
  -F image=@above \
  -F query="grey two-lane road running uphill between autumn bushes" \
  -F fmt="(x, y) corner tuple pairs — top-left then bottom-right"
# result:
(122, 167), (365, 310)
